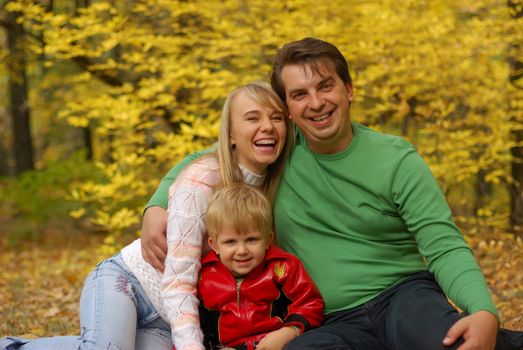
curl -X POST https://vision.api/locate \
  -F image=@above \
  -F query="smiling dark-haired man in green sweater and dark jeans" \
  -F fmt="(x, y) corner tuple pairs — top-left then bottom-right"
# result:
(143, 38), (523, 350)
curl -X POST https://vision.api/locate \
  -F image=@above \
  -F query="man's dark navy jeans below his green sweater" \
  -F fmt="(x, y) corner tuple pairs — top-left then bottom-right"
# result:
(285, 272), (523, 350)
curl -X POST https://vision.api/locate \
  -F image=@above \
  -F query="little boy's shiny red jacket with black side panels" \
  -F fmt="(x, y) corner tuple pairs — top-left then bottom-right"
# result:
(198, 247), (324, 349)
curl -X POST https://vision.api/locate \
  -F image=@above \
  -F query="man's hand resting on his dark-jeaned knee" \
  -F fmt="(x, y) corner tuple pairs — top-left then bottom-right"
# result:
(443, 311), (499, 350)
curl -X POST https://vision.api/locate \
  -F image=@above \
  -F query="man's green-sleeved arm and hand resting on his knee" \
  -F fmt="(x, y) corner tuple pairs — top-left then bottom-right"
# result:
(392, 147), (498, 350)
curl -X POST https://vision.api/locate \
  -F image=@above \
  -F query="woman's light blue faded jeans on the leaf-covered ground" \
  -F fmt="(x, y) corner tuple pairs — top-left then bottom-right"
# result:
(0, 254), (173, 350)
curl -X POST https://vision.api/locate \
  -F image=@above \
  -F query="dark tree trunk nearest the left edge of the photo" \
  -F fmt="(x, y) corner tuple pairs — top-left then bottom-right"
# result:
(5, 12), (34, 174)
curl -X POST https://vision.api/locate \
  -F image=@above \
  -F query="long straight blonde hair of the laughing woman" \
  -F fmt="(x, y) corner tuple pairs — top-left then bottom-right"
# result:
(215, 82), (294, 202)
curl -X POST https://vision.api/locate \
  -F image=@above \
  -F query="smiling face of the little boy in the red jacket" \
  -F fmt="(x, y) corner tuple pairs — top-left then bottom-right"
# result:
(209, 228), (270, 275)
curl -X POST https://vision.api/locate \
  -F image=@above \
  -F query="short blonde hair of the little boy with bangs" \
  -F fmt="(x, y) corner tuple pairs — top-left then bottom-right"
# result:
(205, 183), (272, 241)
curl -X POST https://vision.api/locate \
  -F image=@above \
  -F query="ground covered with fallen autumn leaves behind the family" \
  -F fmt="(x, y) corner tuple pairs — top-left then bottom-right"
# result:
(0, 223), (523, 337)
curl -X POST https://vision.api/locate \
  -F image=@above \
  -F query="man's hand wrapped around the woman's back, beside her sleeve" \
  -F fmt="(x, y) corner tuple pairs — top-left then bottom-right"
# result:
(142, 207), (167, 271)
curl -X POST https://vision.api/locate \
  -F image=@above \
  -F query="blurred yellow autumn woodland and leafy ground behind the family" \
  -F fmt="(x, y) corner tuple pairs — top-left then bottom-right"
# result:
(0, 0), (523, 336)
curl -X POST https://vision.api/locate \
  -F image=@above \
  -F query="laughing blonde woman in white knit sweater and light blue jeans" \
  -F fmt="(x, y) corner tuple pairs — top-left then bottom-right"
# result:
(0, 83), (293, 350)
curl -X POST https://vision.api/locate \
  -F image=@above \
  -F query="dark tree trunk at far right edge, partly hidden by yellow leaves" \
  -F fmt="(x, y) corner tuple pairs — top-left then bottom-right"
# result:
(508, 0), (523, 232)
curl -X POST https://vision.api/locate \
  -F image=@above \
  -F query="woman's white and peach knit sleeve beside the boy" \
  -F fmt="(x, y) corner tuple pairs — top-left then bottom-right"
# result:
(162, 185), (208, 350)
